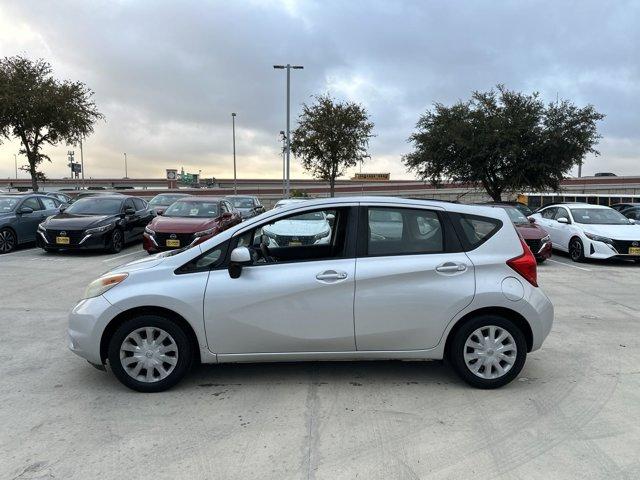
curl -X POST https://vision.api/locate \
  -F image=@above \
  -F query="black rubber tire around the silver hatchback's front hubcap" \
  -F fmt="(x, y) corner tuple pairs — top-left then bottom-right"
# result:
(108, 315), (193, 393)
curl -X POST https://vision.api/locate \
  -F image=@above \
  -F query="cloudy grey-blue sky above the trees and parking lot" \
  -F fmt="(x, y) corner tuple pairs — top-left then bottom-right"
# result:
(0, 0), (640, 179)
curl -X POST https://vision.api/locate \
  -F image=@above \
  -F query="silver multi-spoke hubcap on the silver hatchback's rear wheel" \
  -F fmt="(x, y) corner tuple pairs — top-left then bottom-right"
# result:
(464, 325), (518, 379)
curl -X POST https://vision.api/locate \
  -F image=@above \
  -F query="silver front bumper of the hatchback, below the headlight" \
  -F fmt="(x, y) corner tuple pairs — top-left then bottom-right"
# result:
(68, 295), (120, 365)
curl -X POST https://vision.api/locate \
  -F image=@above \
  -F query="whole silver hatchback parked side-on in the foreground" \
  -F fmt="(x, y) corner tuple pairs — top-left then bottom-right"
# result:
(69, 197), (553, 392)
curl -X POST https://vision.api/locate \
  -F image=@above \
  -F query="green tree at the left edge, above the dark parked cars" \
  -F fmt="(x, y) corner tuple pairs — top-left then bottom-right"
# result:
(0, 56), (104, 192)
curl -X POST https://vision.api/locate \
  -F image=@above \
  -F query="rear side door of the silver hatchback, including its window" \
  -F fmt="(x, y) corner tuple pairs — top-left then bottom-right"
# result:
(354, 205), (475, 351)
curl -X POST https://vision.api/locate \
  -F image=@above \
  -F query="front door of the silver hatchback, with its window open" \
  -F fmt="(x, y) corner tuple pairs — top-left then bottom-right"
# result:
(204, 207), (356, 358)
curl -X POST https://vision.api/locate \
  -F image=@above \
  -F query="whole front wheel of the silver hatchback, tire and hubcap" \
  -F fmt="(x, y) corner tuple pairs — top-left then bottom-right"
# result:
(108, 315), (193, 392)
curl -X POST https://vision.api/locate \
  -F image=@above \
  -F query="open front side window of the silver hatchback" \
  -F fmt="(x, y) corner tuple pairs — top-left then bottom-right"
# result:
(236, 209), (348, 263)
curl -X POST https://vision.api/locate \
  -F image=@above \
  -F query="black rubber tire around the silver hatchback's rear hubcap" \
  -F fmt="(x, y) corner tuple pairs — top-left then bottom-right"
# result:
(449, 315), (527, 389)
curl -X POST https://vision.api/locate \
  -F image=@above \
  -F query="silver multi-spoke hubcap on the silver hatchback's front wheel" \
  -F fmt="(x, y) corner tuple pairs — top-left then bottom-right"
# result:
(120, 327), (178, 383)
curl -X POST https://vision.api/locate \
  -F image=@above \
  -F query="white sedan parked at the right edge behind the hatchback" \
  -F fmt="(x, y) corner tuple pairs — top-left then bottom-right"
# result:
(530, 203), (640, 262)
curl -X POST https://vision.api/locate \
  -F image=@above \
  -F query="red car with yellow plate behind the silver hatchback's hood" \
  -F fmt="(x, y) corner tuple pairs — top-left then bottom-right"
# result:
(143, 196), (242, 254)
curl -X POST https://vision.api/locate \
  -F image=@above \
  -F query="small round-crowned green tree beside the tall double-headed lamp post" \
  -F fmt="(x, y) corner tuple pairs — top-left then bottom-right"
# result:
(291, 95), (373, 197)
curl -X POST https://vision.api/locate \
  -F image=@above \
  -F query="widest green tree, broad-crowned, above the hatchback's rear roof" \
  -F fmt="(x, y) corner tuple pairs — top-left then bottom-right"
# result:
(403, 85), (604, 201)
